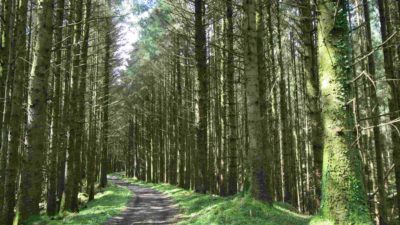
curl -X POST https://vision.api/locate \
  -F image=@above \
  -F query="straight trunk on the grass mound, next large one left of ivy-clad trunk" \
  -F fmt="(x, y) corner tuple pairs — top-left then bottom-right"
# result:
(244, 0), (272, 203)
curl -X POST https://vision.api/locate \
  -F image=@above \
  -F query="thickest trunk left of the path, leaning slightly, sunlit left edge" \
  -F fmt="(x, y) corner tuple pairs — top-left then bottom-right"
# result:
(18, 0), (53, 221)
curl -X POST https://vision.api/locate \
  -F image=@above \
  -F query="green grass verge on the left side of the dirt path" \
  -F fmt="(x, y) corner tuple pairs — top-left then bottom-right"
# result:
(26, 185), (132, 225)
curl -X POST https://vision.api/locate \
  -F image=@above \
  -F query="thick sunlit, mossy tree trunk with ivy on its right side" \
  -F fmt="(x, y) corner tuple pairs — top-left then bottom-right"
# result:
(318, 0), (372, 224)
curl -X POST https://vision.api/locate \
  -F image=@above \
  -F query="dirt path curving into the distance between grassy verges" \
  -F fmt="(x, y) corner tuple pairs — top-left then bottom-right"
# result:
(104, 176), (179, 225)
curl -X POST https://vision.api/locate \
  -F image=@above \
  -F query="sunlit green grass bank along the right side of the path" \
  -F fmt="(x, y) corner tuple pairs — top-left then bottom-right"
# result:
(115, 174), (311, 225)
